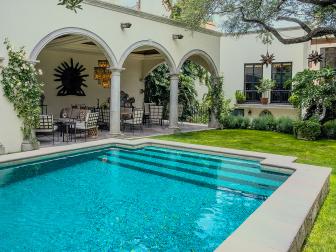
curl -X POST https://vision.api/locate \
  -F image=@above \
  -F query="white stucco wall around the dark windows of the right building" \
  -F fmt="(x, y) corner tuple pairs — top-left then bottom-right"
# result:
(220, 30), (308, 102)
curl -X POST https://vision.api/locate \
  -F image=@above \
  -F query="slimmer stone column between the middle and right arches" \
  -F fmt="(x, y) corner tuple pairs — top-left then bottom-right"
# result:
(169, 74), (179, 129)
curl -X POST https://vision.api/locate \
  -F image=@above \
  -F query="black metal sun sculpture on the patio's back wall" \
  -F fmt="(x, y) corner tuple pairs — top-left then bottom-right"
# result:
(54, 58), (89, 96)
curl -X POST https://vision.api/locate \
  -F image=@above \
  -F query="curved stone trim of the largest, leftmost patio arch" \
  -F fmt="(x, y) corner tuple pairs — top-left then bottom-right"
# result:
(29, 27), (118, 67)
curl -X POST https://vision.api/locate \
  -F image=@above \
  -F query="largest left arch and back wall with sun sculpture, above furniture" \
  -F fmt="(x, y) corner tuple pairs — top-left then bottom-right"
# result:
(30, 28), (117, 141)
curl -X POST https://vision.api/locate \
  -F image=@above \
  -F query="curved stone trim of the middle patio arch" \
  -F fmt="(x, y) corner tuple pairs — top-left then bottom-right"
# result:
(119, 40), (176, 74)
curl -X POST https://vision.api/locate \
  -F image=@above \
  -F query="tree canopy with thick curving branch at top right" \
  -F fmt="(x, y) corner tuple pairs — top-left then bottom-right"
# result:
(172, 0), (336, 44)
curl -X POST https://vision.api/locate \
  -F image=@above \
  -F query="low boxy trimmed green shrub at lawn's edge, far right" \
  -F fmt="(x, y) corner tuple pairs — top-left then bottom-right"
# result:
(294, 120), (321, 140)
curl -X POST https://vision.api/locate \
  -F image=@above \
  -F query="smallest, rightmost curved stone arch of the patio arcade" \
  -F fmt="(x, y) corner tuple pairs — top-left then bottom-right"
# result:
(177, 49), (219, 77)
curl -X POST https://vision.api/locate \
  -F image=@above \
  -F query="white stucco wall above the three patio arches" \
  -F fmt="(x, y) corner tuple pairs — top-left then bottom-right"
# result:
(0, 0), (220, 67)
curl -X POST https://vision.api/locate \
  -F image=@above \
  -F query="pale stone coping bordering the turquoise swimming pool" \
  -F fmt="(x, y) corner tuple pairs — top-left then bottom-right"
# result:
(0, 138), (331, 252)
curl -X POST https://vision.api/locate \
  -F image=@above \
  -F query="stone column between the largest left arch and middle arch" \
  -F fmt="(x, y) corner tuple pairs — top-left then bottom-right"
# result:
(110, 68), (124, 135)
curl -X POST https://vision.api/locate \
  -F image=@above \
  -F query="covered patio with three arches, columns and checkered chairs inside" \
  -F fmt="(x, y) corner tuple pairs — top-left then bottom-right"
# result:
(34, 29), (217, 147)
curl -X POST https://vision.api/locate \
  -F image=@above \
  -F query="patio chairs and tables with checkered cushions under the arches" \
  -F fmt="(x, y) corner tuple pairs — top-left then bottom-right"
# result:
(35, 103), (171, 144)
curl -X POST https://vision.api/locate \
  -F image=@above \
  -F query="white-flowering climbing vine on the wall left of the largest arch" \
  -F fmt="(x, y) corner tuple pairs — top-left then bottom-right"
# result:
(1, 39), (43, 142)
